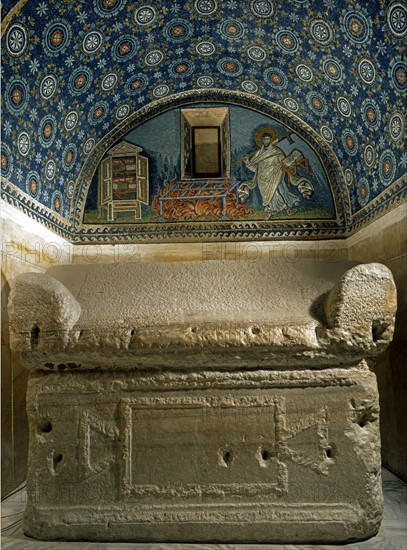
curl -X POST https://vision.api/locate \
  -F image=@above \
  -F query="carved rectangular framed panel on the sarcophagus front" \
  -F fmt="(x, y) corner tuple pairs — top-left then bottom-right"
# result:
(120, 396), (287, 498)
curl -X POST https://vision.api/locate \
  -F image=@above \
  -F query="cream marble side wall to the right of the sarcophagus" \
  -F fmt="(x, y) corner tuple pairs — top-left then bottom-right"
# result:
(347, 203), (407, 479)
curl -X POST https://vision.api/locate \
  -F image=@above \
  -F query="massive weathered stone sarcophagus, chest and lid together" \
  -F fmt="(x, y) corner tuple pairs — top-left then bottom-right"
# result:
(9, 259), (396, 542)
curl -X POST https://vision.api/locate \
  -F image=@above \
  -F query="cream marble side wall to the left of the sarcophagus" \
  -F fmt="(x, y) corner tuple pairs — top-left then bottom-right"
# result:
(0, 201), (73, 496)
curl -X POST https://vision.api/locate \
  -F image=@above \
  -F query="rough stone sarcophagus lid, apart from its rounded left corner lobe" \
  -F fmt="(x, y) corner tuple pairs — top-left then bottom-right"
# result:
(8, 260), (395, 370)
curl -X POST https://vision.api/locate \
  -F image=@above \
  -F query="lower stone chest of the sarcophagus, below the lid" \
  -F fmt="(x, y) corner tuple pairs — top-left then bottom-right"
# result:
(24, 364), (382, 542)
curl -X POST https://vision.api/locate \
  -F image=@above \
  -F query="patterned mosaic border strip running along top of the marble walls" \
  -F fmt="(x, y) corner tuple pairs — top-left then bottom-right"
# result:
(1, 175), (407, 244)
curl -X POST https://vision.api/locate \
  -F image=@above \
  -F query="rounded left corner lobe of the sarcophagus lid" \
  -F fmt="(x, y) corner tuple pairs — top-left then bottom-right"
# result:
(9, 273), (81, 352)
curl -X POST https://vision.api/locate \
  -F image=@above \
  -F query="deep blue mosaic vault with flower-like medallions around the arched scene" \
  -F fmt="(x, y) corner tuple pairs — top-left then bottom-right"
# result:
(1, 0), (407, 242)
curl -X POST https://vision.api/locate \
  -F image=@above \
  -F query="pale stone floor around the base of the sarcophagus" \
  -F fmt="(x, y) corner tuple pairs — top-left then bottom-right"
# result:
(1, 469), (407, 550)
